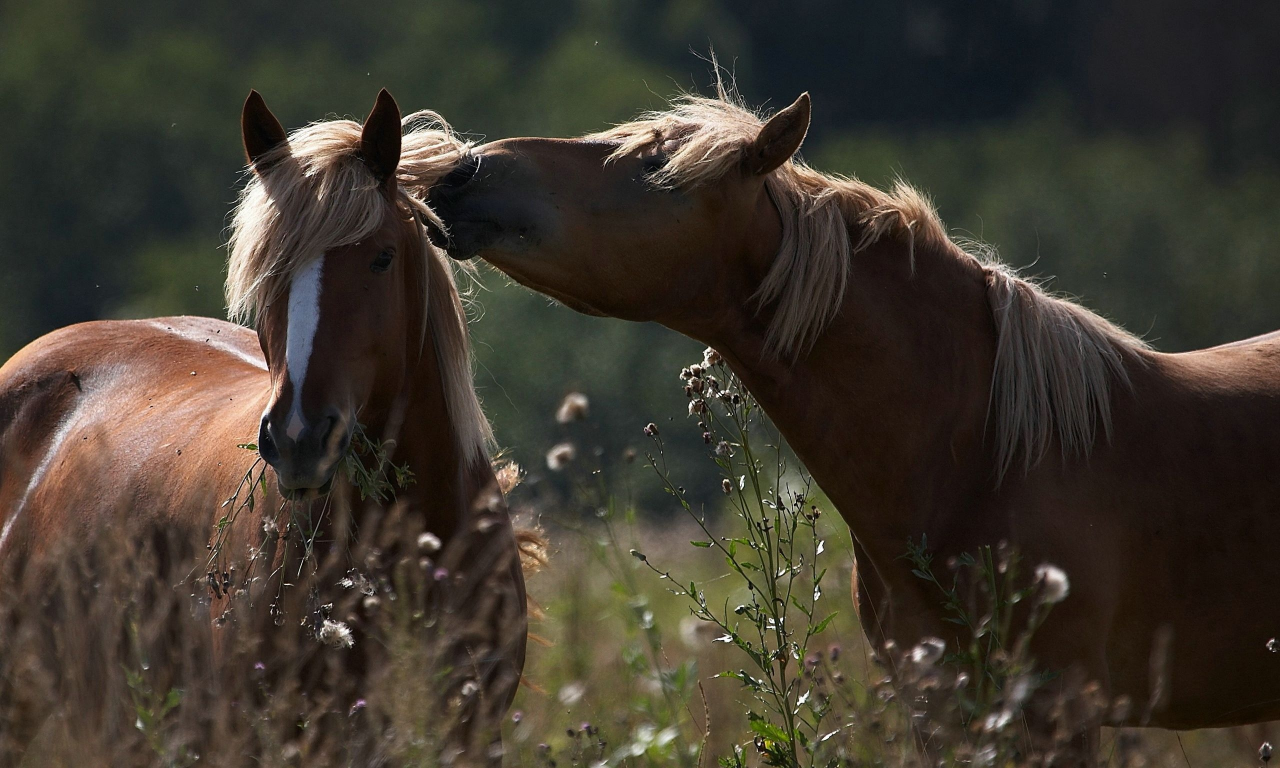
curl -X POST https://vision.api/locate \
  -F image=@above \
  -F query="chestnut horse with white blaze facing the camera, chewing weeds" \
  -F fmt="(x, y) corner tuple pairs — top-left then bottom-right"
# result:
(0, 91), (526, 764)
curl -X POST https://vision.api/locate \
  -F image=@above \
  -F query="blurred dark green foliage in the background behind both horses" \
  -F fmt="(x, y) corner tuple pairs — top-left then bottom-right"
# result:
(0, 0), (1280, 517)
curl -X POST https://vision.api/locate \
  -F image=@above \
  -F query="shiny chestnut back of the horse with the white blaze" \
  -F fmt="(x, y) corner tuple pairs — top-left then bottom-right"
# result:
(0, 317), (269, 556)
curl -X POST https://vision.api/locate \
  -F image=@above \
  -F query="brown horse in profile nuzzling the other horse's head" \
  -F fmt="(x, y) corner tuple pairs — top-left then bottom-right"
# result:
(430, 92), (1280, 742)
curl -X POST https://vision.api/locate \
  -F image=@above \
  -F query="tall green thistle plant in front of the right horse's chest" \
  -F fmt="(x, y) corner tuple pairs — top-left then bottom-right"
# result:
(631, 349), (838, 768)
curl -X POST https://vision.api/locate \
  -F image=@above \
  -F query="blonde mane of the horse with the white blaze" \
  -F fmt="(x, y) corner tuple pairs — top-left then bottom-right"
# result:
(227, 111), (493, 457)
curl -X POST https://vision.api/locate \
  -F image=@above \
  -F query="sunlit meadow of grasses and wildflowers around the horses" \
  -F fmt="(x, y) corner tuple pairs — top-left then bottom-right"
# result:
(0, 351), (1270, 768)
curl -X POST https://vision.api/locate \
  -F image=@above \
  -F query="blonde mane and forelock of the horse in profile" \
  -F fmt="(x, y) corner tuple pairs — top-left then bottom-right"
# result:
(588, 91), (1146, 484)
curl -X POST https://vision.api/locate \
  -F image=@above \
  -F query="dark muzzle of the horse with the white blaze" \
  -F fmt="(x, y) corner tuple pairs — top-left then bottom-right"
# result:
(257, 407), (347, 489)
